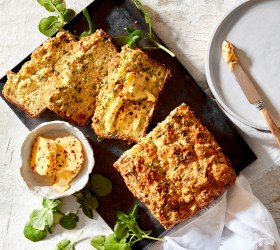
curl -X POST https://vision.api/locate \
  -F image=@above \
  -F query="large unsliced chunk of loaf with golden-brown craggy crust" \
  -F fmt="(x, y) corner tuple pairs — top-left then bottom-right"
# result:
(114, 104), (236, 229)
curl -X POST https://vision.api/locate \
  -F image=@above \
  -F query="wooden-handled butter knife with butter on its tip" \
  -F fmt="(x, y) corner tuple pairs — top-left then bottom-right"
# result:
(222, 41), (280, 147)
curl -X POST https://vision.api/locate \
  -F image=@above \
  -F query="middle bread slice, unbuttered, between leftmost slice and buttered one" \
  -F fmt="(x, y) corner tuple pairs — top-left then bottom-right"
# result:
(44, 30), (117, 126)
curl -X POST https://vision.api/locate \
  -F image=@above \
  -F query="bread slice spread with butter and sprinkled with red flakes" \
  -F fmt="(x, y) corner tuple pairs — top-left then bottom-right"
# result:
(92, 45), (170, 142)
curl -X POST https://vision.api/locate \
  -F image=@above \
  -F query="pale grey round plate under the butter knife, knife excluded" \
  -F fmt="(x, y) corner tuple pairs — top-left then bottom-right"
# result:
(205, 0), (280, 130)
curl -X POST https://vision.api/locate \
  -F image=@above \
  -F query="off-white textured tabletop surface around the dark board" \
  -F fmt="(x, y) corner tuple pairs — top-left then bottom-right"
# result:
(0, 0), (280, 250)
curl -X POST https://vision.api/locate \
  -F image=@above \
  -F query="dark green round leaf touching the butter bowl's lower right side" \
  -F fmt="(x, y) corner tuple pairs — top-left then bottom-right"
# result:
(91, 174), (112, 197)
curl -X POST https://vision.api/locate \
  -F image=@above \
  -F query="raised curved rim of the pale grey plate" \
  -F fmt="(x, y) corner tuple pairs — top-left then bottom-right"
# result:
(205, 0), (270, 131)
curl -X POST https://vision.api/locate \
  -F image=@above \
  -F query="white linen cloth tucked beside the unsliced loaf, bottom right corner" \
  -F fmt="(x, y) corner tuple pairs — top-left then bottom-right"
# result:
(153, 174), (280, 250)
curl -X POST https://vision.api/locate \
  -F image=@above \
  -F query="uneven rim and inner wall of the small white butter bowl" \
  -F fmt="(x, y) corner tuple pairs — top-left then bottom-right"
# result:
(20, 120), (95, 199)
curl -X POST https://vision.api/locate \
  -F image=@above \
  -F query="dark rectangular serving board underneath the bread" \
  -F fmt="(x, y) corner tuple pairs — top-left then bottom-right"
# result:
(0, 0), (256, 249)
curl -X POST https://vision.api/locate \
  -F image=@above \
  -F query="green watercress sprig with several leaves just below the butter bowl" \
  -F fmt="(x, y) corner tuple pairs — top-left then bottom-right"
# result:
(24, 174), (111, 242)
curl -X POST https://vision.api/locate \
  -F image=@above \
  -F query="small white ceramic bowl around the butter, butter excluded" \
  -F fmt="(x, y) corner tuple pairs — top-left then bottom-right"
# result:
(20, 121), (95, 199)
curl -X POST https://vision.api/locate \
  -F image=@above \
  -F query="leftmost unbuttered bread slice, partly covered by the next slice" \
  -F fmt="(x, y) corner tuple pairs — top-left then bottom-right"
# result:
(2, 31), (75, 117)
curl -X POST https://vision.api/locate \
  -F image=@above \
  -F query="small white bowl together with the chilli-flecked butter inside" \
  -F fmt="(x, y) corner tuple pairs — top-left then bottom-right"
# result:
(20, 121), (95, 199)
